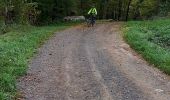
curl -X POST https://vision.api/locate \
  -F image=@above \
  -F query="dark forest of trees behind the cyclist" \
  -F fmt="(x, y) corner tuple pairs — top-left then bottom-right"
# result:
(0, 0), (170, 25)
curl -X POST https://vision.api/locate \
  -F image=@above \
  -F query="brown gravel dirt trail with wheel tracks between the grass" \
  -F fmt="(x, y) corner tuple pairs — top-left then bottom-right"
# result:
(18, 23), (170, 100)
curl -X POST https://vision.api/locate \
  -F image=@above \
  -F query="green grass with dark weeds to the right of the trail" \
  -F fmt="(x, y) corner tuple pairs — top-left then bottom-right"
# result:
(124, 19), (170, 75)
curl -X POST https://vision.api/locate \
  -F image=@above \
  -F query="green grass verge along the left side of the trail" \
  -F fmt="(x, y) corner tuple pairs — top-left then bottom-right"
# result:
(0, 23), (79, 100)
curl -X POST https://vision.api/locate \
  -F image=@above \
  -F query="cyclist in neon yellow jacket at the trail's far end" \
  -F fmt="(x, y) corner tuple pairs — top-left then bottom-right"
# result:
(88, 5), (97, 26)
